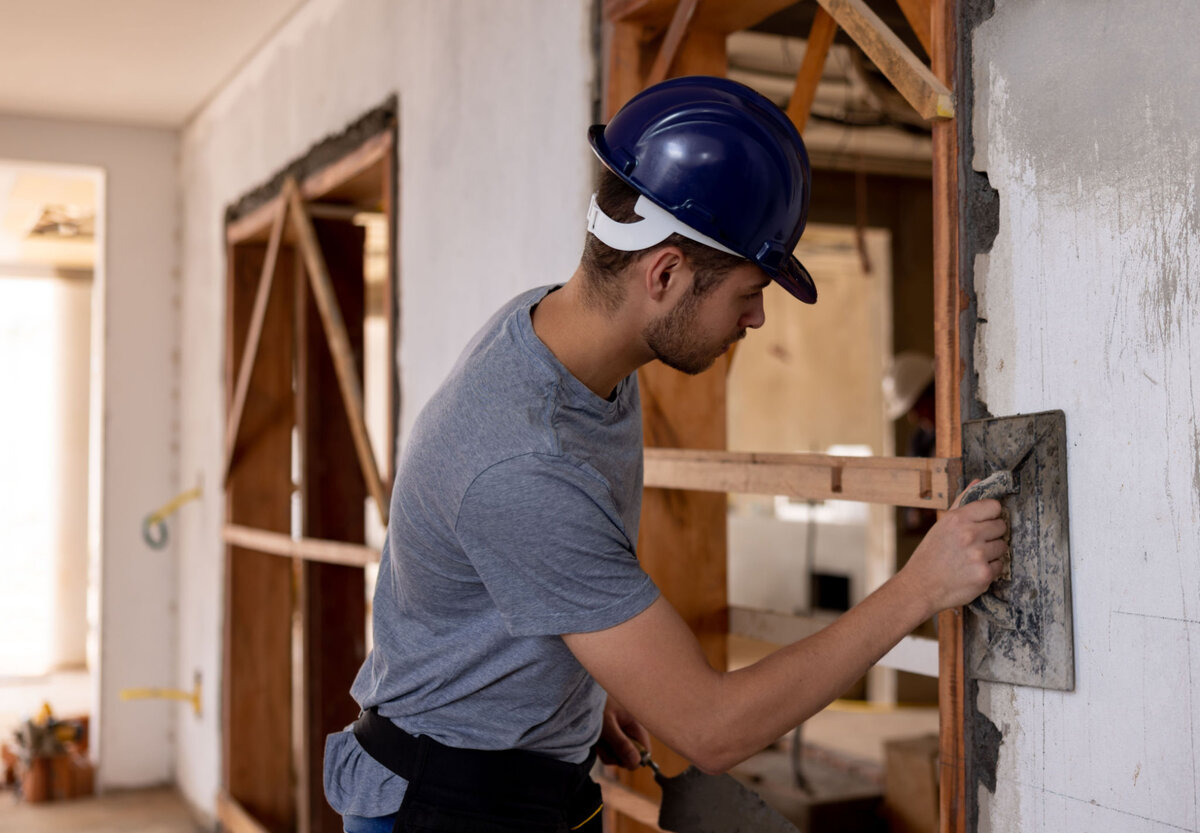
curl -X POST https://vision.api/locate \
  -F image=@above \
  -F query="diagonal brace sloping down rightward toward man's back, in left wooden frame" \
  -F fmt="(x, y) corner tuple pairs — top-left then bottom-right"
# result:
(283, 178), (388, 526)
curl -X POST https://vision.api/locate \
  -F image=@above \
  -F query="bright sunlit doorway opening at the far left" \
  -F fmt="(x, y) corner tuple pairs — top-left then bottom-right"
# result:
(0, 161), (104, 777)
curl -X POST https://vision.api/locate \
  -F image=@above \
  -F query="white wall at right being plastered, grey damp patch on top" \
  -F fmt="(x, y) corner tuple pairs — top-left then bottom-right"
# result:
(974, 0), (1200, 833)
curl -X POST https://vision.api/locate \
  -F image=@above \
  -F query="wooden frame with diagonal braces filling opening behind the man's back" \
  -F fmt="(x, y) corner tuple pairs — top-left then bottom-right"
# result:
(218, 120), (398, 833)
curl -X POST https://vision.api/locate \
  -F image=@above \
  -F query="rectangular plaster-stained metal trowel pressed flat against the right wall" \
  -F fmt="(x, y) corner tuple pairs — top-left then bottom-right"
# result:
(960, 410), (1075, 691)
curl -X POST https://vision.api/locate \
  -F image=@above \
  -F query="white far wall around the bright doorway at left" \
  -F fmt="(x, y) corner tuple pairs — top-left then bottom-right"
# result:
(0, 115), (179, 789)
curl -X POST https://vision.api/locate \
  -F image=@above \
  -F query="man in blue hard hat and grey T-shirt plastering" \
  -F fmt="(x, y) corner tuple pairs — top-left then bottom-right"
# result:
(325, 78), (1006, 833)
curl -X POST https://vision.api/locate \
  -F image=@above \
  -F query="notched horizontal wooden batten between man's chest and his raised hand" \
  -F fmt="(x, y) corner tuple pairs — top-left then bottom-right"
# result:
(644, 448), (962, 509)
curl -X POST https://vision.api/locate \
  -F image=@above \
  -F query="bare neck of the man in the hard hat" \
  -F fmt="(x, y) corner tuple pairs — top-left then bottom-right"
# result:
(533, 270), (647, 398)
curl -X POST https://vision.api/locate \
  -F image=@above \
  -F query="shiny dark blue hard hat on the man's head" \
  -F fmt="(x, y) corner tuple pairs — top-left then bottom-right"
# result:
(588, 76), (817, 304)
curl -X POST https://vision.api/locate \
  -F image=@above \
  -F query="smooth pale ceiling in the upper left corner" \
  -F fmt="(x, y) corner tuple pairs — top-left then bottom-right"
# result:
(0, 0), (305, 127)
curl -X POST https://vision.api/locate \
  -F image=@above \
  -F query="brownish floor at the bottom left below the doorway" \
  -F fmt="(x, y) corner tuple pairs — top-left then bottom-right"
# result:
(0, 787), (202, 833)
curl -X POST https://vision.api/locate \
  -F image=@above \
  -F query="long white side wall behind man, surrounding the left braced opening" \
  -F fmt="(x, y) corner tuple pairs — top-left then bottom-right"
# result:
(176, 0), (593, 813)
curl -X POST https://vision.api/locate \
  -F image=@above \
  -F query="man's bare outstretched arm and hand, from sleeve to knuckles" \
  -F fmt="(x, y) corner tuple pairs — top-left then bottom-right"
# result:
(563, 501), (1007, 772)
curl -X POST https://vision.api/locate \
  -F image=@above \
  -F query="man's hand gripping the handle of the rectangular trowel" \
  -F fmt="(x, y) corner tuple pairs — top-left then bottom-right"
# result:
(898, 484), (1008, 613)
